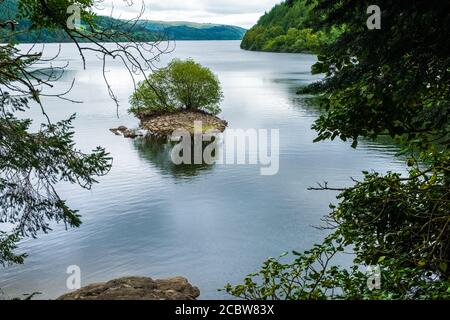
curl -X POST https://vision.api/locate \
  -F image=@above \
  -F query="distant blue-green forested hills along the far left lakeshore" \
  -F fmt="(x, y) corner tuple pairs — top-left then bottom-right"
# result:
(0, 0), (247, 43)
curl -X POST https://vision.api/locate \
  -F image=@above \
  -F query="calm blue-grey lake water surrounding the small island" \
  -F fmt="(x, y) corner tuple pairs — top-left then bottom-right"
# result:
(0, 41), (403, 299)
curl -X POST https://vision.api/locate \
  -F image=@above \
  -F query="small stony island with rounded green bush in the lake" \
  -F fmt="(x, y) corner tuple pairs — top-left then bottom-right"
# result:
(111, 59), (228, 138)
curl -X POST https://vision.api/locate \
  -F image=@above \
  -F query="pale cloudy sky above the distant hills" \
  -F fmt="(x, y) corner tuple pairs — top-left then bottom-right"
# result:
(97, 0), (281, 28)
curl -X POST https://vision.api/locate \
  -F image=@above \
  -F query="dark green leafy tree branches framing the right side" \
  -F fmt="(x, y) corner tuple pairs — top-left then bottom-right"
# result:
(226, 0), (450, 300)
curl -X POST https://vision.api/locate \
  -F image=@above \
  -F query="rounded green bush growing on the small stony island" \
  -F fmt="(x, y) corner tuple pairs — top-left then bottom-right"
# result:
(129, 59), (223, 116)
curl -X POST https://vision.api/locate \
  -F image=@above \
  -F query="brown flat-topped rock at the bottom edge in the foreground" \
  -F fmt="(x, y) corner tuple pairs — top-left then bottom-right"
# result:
(58, 277), (200, 300)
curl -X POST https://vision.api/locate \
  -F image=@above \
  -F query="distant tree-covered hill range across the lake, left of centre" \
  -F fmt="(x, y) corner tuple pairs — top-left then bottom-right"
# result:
(0, 0), (246, 43)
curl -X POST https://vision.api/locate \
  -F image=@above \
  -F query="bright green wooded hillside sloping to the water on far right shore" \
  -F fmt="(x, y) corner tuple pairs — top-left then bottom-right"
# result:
(241, 0), (340, 53)
